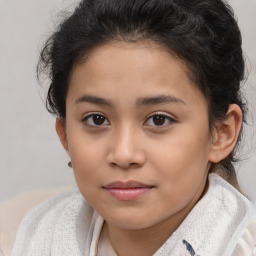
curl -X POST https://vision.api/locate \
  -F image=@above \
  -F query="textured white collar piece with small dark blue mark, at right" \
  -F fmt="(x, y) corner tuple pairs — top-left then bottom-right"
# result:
(152, 174), (256, 256)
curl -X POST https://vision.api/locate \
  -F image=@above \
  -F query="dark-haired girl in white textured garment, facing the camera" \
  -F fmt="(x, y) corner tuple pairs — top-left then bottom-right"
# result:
(12, 0), (256, 256)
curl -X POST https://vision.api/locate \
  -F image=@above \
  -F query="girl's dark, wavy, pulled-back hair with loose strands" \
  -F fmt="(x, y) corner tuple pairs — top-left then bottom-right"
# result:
(38, 0), (245, 185)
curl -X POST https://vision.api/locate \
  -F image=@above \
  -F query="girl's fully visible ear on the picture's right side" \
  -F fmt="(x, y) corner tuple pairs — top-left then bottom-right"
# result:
(209, 104), (242, 163)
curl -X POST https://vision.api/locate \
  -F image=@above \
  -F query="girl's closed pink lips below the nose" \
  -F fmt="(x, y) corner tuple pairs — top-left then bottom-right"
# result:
(104, 181), (153, 201)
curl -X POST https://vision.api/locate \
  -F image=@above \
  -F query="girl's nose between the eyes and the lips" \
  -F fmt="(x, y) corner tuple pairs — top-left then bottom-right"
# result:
(107, 127), (146, 169)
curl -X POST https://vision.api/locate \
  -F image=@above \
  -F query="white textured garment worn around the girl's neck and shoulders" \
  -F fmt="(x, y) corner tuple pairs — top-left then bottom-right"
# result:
(12, 174), (256, 256)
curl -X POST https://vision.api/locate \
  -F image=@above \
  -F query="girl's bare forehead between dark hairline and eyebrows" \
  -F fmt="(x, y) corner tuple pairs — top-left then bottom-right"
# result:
(69, 41), (207, 106)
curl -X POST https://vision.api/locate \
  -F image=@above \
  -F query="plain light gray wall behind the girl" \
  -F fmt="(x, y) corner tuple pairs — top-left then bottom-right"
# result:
(0, 0), (256, 203)
